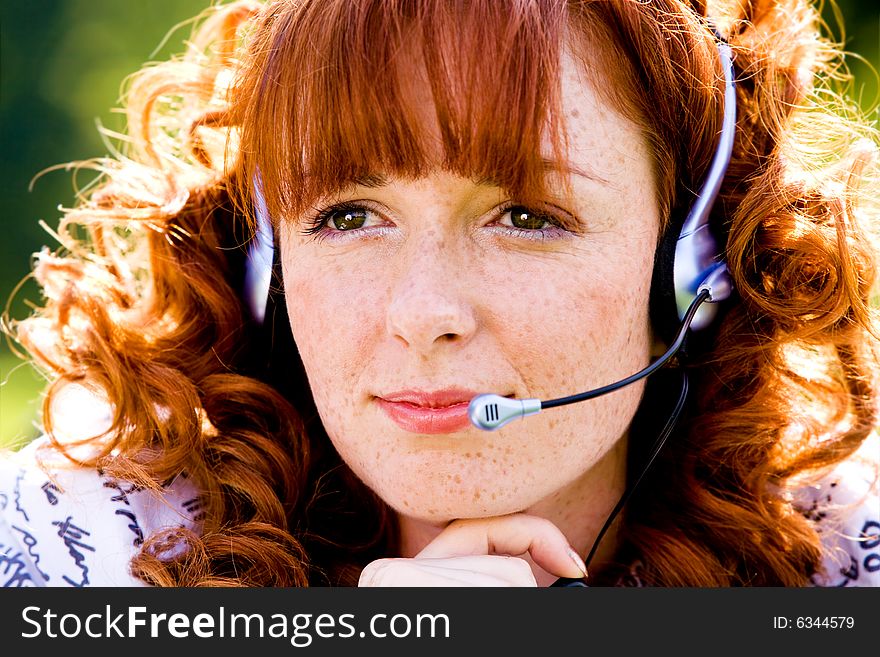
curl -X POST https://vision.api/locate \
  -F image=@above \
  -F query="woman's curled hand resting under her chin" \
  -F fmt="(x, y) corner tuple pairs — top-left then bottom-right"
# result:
(358, 513), (586, 586)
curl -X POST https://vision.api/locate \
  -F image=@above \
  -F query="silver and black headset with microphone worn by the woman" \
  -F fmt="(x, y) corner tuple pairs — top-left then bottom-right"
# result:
(242, 31), (737, 586)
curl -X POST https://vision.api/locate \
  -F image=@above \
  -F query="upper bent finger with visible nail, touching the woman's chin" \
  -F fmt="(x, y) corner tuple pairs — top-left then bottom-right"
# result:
(416, 513), (586, 578)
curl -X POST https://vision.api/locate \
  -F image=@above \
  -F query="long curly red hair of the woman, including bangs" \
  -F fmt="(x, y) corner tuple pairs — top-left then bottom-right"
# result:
(8, 0), (880, 586)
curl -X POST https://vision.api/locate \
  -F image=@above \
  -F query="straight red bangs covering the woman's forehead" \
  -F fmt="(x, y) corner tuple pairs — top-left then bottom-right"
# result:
(236, 0), (566, 217)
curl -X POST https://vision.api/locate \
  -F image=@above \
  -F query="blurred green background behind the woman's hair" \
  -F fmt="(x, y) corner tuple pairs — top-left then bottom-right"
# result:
(0, 0), (880, 447)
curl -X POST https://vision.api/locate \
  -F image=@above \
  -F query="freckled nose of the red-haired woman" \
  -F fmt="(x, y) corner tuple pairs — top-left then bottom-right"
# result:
(387, 240), (477, 355)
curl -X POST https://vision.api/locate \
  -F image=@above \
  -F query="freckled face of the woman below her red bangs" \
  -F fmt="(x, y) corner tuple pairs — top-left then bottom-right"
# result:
(280, 50), (659, 524)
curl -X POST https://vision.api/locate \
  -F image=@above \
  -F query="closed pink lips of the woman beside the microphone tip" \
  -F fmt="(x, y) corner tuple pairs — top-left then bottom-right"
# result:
(376, 388), (478, 434)
